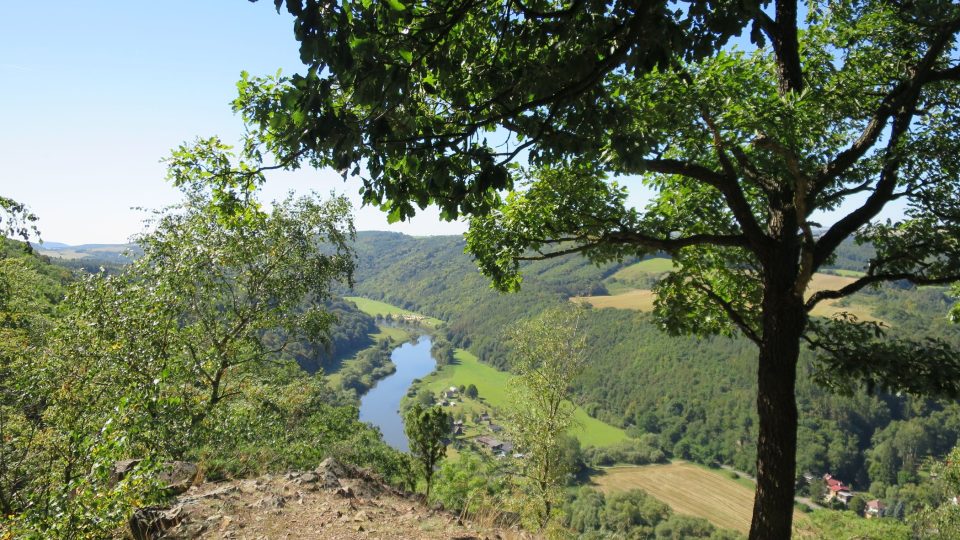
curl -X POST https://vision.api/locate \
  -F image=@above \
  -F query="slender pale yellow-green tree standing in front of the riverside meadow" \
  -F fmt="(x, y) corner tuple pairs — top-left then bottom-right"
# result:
(510, 307), (586, 529)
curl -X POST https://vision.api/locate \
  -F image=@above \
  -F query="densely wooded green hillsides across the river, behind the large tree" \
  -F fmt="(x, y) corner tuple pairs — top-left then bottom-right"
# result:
(355, 232), (960, 511)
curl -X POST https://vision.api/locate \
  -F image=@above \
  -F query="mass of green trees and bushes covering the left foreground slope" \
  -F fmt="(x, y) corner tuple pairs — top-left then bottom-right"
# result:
(0, 169), (412, 538)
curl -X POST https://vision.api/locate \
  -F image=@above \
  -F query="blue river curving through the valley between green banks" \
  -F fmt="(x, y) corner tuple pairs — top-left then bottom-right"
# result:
(360, 336), (437, 452)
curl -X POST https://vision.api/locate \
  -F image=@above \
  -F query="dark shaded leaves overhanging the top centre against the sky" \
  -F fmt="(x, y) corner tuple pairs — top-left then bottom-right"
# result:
(242, 0), (757, 220)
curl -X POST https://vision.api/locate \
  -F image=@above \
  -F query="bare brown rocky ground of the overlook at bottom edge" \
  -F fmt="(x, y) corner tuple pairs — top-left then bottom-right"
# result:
(130, 459), (525, 540)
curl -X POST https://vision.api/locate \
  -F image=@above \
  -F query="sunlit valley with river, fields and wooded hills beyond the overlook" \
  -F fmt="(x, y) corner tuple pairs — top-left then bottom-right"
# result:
(7, 233), (960, 538)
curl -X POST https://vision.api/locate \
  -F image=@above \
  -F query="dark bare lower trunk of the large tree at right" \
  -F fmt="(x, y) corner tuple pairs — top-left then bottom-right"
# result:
(750, 286), (806, 540)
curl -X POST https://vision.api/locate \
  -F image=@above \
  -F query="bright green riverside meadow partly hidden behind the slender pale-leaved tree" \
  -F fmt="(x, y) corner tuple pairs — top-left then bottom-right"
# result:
(420, 349), (627, 446)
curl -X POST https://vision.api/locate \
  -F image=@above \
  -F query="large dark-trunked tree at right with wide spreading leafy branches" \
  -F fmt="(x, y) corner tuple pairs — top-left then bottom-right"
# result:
(242, 0), (960, 538)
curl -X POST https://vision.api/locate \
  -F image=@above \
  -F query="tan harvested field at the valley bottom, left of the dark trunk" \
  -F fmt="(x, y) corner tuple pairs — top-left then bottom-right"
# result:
(592, 461), (809, 533)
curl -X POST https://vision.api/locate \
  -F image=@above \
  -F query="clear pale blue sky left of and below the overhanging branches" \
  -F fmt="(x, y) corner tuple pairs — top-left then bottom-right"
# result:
(0, 0), (465, 244)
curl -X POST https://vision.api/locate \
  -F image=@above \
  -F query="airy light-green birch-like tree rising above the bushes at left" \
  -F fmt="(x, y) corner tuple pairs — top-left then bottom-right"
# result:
(51, 178), (354, 457)
